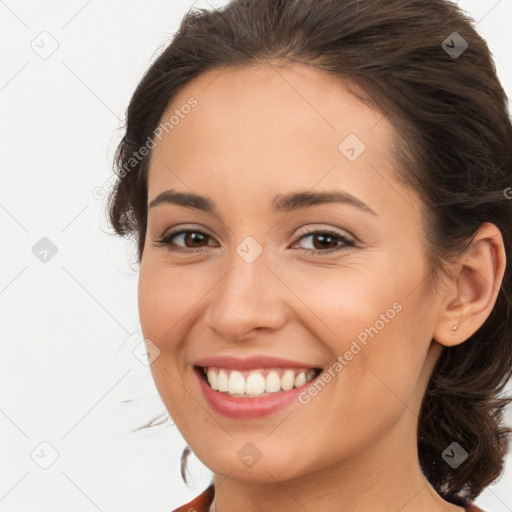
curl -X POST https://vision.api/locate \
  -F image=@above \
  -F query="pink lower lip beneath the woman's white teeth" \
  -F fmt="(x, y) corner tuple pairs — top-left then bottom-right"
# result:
(194, 368), (318, 418)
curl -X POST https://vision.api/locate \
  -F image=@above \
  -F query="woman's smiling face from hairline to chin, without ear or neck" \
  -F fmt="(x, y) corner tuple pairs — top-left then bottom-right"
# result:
(139, 64), (446, 482)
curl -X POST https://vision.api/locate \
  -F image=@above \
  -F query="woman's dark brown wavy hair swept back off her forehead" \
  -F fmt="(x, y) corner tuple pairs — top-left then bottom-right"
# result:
(109, 0), (512, 501)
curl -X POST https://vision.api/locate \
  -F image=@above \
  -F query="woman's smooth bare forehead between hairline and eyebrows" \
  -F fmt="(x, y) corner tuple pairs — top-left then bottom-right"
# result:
(148, 63), (406, 218)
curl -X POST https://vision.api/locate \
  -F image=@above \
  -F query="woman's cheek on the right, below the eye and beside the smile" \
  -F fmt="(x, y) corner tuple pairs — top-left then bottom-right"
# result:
(288, 258), (433, 396)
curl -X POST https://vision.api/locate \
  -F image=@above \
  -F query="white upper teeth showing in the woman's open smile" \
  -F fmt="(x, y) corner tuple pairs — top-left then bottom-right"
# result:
(204, 368), (315, 398)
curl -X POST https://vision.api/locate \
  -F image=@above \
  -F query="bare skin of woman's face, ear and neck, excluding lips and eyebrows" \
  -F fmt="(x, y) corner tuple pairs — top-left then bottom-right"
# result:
(139, 62), (505, 512)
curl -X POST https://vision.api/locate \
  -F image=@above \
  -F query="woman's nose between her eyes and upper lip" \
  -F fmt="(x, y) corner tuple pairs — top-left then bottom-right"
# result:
(204, 247), (289, 341)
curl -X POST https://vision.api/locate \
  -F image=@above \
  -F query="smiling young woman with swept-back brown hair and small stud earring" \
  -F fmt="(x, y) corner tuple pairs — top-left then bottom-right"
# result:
(109, 0), (512, 512)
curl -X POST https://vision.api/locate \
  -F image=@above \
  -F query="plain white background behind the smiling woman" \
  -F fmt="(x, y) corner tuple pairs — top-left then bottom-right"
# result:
(0, 0), (512, 512)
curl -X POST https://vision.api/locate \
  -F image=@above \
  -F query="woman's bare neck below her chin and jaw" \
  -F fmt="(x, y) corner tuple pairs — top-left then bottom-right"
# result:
(208, 411), (464, 512)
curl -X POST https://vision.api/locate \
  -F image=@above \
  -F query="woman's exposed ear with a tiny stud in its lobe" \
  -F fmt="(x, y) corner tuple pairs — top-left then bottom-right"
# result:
(433, 222), (507, 347)
